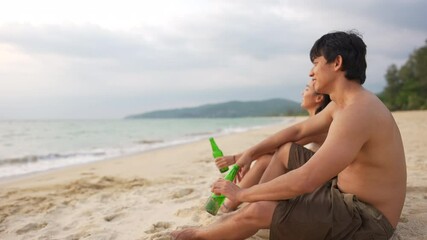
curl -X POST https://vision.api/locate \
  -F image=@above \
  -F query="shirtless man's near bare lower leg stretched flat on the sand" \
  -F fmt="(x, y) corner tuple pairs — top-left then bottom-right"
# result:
(172, 201), (277, 240)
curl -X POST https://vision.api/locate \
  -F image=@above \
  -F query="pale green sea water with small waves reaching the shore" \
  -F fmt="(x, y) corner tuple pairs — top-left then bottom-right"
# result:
(0, 117), (293, 178)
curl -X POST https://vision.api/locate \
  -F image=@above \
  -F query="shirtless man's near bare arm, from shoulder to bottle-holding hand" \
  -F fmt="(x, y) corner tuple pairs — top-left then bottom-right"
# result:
(218, 105), (371, 202)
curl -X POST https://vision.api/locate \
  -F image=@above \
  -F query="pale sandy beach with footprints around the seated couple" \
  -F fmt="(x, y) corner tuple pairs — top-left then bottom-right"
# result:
(0, 111), (427, 240)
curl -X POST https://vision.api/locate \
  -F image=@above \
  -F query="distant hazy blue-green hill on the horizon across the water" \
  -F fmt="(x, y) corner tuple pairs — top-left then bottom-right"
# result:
(126, 98), (303, 119)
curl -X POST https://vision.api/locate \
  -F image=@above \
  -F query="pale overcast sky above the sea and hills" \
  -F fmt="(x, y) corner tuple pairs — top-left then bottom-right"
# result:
(0, 0), (427, 119)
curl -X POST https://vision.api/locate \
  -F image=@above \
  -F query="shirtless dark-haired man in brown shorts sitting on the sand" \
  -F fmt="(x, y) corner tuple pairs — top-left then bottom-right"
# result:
(172, 32), (406, 240)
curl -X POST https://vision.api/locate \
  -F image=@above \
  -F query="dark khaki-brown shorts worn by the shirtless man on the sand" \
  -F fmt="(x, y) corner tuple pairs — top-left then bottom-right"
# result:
(270, 144), (394, 240)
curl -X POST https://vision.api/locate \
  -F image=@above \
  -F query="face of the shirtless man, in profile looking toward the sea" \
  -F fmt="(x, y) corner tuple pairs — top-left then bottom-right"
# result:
(309, 56), (334, 94)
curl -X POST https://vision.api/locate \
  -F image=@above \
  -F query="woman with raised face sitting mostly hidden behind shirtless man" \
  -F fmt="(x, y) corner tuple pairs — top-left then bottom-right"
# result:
(215, 80), (331, 212)
